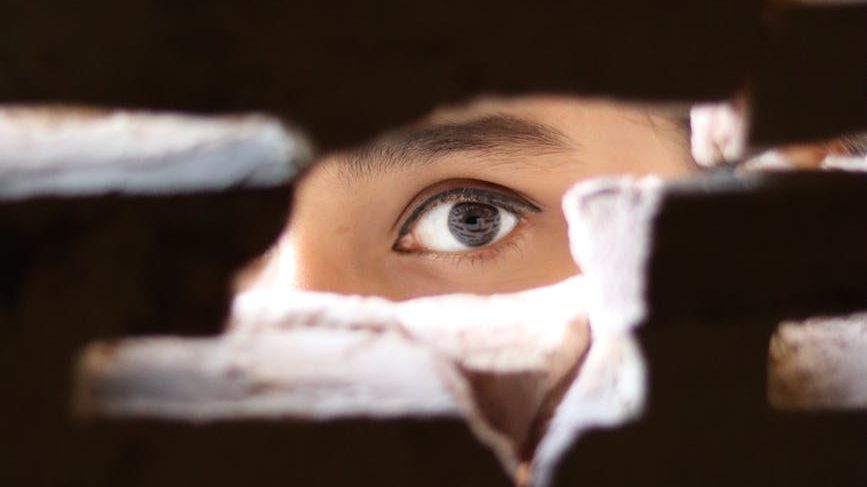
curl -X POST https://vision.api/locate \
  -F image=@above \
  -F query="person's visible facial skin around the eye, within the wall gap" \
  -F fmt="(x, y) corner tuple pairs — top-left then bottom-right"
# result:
(262, 97), (695, 300)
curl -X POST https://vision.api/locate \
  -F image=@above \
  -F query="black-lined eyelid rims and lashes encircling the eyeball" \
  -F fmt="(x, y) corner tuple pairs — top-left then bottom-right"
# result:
(392, 181), (542, 265)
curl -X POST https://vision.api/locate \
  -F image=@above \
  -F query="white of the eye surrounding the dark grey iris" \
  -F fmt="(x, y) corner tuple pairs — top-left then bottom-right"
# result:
(412, 202), (518, 253)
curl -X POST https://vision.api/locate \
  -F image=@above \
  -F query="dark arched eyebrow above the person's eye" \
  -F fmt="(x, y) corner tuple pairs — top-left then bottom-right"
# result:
(343, 115), (572, 177)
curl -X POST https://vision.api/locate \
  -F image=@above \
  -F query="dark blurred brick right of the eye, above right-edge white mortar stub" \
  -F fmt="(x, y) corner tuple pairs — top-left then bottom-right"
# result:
(647, 172), (867, 322)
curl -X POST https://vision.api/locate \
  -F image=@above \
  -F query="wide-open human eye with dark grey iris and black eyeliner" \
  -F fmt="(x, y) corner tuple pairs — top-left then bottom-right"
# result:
(392, 182), (541, 255)
